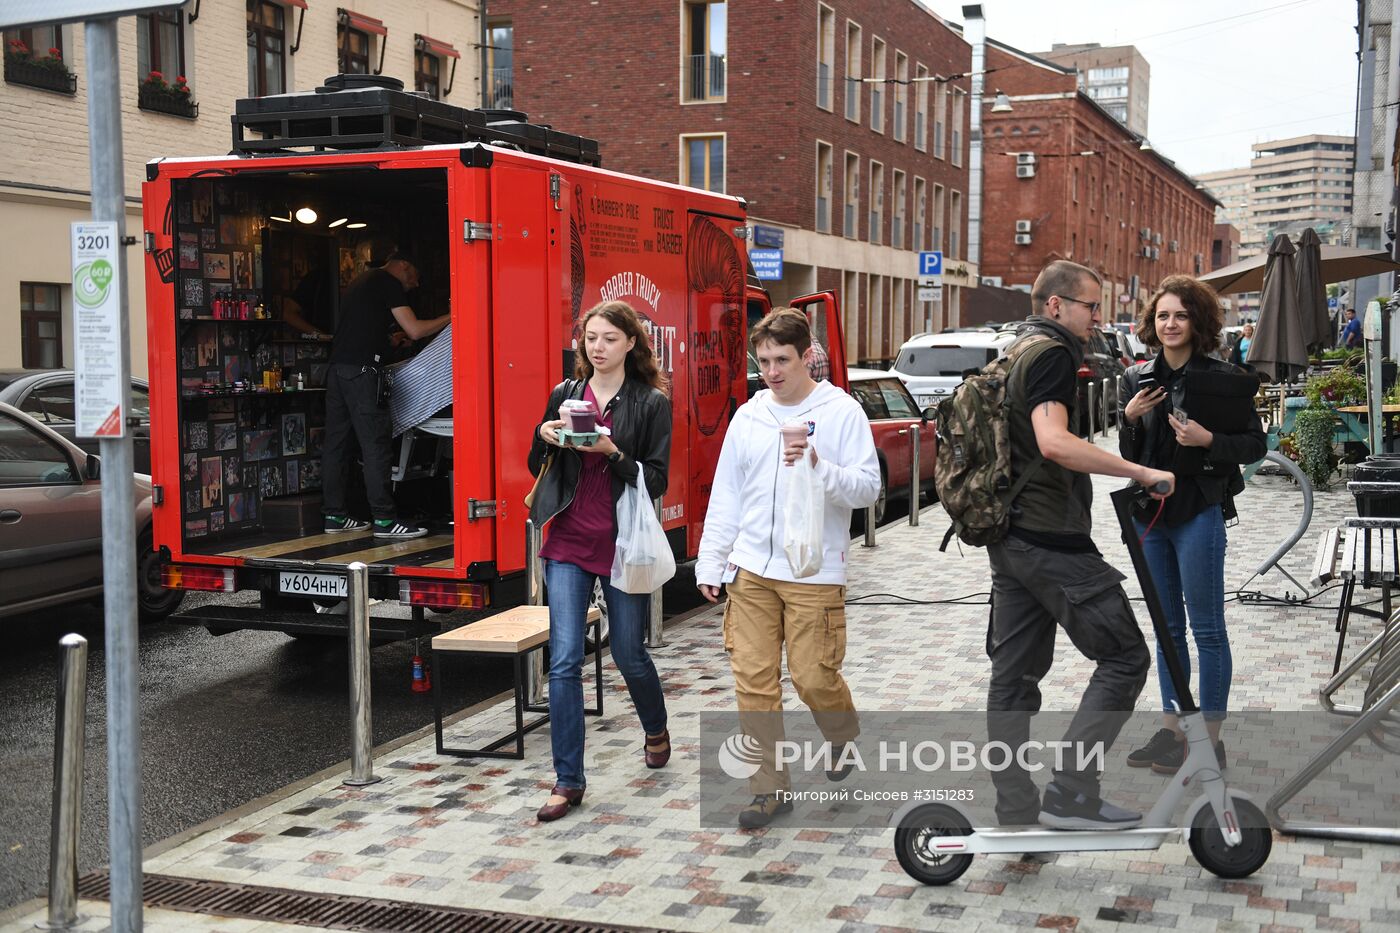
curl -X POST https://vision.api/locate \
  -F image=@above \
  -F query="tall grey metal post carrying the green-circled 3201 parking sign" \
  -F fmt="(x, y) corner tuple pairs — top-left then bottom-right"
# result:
(78, 18), (143, 933)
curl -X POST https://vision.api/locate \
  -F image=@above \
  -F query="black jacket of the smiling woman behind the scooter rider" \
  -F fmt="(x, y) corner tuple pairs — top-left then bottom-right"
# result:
(1119, 353), (1268, 504)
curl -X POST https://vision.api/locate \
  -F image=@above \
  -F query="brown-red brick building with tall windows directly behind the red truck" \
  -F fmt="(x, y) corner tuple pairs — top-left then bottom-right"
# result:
(487, 0), (977, 361)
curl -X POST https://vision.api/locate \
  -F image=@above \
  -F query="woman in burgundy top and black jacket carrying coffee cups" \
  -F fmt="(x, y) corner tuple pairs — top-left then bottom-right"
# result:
(529, 301), (671, 822)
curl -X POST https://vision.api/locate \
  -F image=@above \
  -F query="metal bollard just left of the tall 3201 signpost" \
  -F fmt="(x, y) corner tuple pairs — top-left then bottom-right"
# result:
(39, 635), (87, 930)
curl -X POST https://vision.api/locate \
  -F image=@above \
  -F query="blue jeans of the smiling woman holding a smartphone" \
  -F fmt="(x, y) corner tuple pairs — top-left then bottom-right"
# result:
(1133, 506), (1231, 720)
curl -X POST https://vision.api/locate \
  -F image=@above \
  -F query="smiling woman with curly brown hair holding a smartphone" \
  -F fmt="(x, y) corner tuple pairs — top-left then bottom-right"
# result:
(1119, 275), (1267, 775)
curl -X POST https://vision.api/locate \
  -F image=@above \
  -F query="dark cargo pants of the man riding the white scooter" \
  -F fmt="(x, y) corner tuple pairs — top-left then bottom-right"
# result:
(987, 529), (1151, 825)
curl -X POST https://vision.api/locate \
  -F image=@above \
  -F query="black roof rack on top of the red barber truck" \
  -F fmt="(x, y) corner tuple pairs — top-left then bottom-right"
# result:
(232, 74), (602, 165)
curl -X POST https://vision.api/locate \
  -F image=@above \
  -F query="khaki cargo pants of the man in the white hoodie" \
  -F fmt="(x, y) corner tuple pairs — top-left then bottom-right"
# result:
(724, 570), (860, 794)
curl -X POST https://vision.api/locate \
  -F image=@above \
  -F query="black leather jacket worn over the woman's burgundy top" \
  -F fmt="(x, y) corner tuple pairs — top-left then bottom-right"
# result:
(529, 378), (671, 528)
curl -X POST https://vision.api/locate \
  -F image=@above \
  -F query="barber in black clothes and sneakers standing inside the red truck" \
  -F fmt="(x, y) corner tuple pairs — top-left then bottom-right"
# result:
(321, 252), (451, 538)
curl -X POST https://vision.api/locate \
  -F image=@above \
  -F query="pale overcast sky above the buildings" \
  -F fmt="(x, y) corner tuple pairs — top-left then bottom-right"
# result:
(921, 0), (1357, 174)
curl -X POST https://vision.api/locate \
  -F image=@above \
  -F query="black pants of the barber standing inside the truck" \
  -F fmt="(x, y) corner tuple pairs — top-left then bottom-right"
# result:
(321, 363), (398, 518)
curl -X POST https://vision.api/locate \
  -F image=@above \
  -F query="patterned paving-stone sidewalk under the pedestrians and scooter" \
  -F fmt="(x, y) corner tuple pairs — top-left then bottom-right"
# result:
(13, 441), (1400, 930)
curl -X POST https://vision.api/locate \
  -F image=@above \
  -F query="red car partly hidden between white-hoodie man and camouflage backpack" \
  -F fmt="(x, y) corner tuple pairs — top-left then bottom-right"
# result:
(850, 368), (934, 524)
